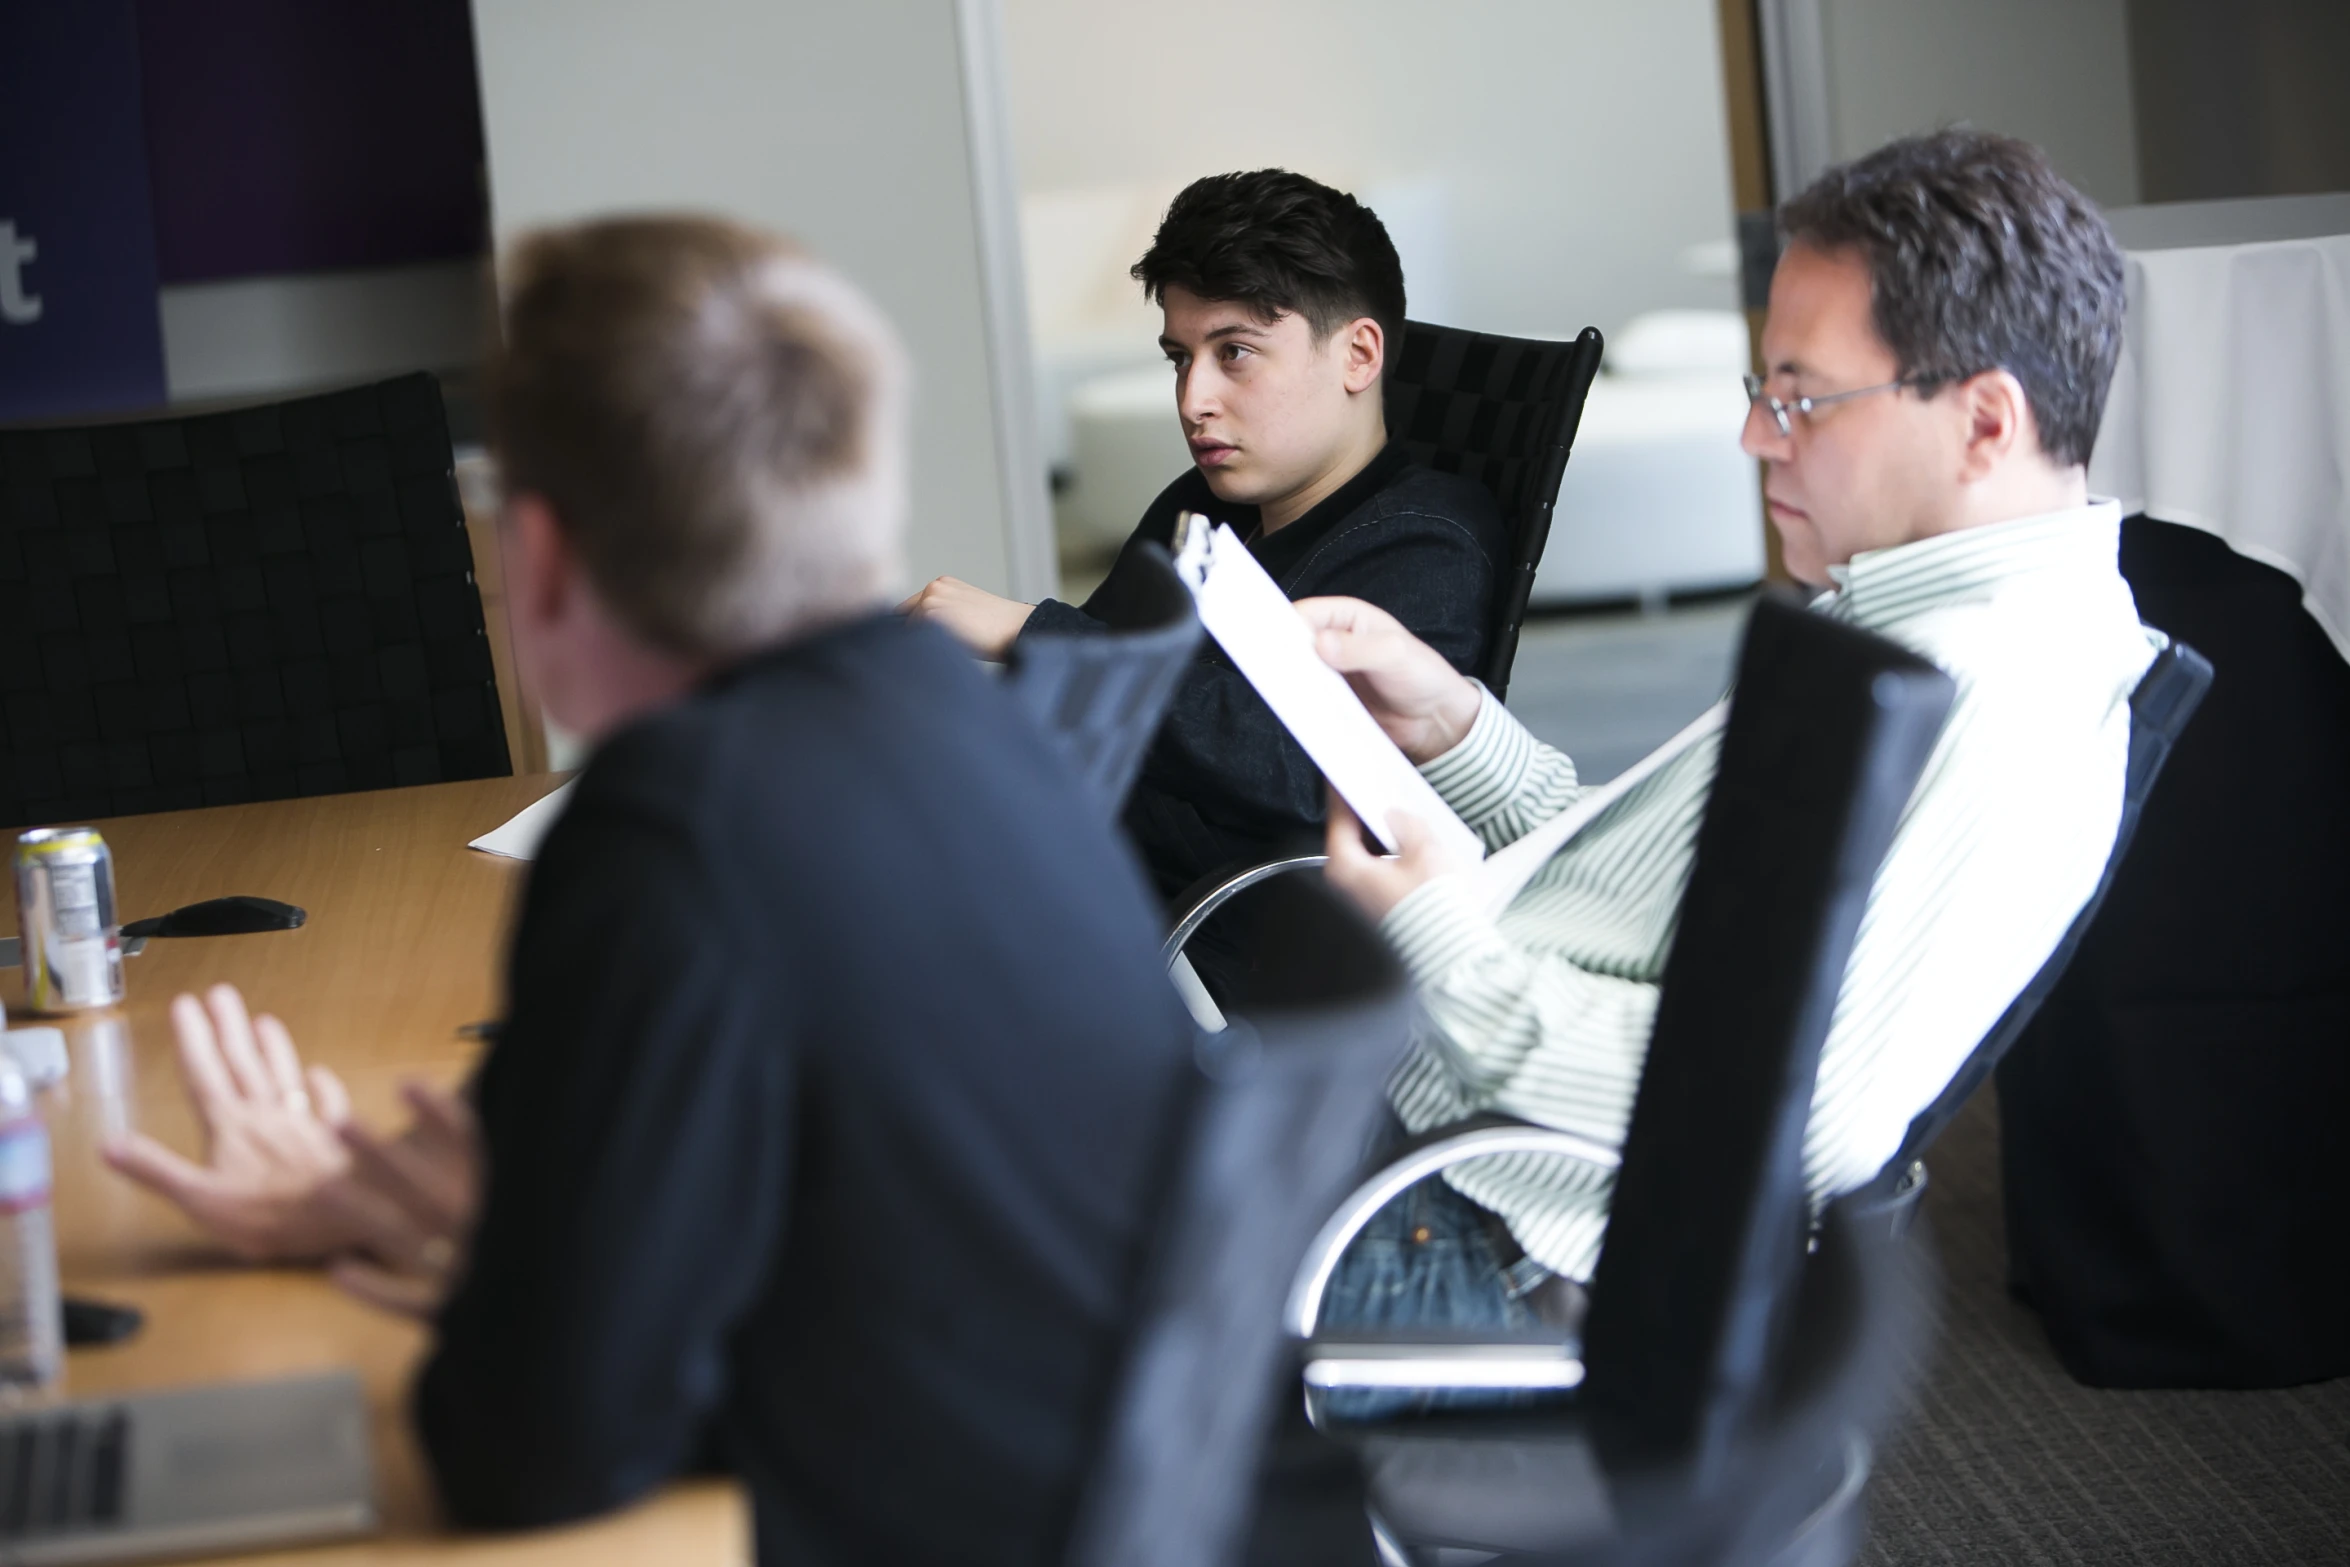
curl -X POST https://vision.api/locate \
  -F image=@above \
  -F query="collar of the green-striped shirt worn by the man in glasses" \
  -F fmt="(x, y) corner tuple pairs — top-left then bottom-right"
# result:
(1828, 496), (2122, 627)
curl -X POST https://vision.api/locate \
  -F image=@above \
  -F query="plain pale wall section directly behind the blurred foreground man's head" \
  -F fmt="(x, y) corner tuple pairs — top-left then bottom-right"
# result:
(475, 0), (1053, 597)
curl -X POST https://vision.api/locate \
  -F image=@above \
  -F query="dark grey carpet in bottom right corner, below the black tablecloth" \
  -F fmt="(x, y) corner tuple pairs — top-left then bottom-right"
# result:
(1861, 1092), (2350, 1567)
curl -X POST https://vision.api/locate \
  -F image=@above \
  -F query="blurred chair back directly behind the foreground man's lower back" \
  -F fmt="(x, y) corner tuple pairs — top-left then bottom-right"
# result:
(1067, 876), (1410, 1567)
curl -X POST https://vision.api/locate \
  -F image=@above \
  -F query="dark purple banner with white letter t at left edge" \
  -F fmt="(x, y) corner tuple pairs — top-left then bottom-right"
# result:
(0, 0), (165, 423)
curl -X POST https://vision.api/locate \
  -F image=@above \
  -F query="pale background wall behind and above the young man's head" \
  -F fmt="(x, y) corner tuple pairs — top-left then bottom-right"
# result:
(1003, 0), (1734, 348)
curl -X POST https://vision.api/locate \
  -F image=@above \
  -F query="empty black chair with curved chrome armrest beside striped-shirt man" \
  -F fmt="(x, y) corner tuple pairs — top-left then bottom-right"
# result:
(1285, 599), (1955, 1558)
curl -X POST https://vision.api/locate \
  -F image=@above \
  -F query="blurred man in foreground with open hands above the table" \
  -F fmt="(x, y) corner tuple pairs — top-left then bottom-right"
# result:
(110, 218), (1191, 1562)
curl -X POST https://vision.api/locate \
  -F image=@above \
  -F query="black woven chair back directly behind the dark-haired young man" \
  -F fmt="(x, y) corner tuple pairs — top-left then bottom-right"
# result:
(1387, 322), (1605, 698)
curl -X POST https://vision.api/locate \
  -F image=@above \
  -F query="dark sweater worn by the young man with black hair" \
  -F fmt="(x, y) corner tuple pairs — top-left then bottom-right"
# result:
(1020, 444), (1509, 897)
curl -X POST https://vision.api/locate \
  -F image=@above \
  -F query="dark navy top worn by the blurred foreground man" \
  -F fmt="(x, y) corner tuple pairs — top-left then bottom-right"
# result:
(416, 618), (1194, 1562)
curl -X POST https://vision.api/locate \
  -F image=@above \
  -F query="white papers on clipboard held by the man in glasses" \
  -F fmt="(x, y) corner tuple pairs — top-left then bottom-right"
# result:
(1175, 512), (1485, 860)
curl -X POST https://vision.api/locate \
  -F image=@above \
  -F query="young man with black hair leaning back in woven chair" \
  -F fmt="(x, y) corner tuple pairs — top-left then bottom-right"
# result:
(905, 169), (1506, 906)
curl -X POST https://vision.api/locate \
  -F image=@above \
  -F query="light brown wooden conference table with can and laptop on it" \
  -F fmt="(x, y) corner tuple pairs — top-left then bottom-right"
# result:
(0, 775), (750, 1567)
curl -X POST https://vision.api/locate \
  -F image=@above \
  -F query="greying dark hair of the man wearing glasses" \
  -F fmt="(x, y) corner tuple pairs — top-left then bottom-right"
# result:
(1779, 129), (2122, 465)
